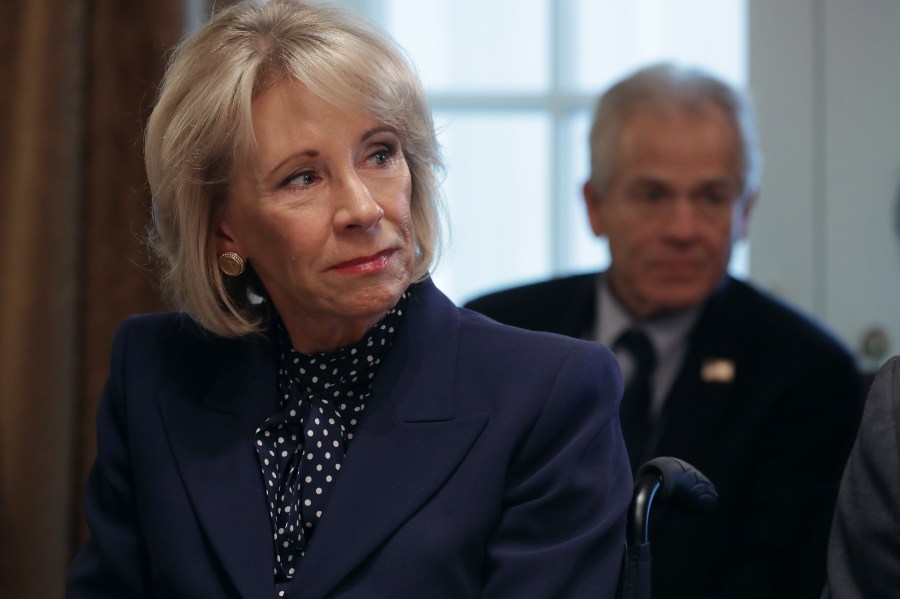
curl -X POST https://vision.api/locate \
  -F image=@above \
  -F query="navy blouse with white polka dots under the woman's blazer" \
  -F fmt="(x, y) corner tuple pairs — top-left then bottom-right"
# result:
(256, 292), (408, 582)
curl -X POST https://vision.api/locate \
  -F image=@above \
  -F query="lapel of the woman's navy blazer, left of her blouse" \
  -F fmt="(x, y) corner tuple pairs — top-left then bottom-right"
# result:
(161, 342), (277, 597)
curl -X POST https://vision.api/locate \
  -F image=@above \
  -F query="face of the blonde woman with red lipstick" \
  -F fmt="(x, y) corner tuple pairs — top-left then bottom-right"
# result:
(216, 78), (414, 353)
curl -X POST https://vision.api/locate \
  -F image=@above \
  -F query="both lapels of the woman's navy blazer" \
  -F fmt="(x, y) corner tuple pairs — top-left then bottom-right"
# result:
(163, 281), (487, 598)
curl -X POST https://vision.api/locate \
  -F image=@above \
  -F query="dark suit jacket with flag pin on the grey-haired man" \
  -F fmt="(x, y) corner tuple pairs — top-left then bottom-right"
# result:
(468, 274), (861, 599)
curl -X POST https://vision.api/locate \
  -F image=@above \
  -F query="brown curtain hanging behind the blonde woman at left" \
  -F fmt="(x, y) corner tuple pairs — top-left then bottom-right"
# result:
(0, 0), (187, 599)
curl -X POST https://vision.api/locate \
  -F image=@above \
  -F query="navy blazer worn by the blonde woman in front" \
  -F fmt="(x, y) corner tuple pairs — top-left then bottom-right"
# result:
(69, 282), (631, 599)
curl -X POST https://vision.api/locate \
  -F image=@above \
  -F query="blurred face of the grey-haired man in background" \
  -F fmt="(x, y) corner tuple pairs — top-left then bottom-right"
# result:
(584, 105), (755, 318)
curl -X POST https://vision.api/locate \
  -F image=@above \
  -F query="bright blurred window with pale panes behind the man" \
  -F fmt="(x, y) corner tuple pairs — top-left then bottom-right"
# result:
(336, 0), (748, 303)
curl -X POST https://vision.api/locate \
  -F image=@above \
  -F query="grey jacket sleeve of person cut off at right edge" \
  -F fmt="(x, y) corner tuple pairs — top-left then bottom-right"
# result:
(822, 356), (900, 599)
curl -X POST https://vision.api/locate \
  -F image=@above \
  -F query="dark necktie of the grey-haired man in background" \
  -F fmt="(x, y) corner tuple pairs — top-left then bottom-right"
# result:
(614, 329), (656, 472)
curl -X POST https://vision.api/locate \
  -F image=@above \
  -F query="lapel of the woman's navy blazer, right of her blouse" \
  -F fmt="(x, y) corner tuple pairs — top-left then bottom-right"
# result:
(297, 282), (487, 598)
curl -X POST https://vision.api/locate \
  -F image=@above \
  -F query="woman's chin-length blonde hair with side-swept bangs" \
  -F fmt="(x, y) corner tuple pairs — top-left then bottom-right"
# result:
(144, 0), (443, 337)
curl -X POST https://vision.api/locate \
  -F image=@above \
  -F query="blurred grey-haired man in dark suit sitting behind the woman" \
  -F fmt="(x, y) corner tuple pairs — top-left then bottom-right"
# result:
(467, 65), (861, 599)
